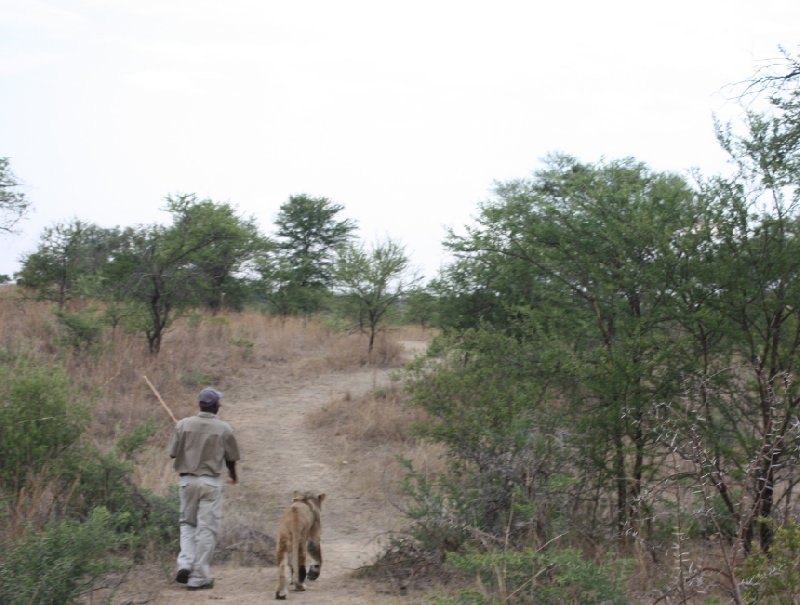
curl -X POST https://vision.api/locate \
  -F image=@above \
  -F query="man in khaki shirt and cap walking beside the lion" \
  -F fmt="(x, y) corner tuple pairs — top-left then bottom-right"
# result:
(169, 387), (239, 590)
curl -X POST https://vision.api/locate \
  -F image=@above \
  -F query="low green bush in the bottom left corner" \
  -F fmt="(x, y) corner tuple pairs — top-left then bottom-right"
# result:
(0, 508), (126, 605)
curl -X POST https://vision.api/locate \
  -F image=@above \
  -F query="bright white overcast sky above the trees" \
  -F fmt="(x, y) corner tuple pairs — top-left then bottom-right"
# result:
(0, 0), (800, 277)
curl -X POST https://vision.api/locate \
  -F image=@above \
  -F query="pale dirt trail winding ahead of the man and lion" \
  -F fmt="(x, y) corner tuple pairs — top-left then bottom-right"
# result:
(128, 346), (422, 605)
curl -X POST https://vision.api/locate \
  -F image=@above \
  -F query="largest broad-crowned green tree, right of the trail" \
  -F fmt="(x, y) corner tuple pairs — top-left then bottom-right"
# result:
(432, 155), (696, 542)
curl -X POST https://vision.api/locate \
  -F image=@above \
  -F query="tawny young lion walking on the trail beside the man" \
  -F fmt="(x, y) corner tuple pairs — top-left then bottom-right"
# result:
(275, 491), (325, 599)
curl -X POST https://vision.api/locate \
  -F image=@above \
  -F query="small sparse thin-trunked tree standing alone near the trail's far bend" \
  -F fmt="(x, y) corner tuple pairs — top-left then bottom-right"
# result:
(333, 240), (419, 355)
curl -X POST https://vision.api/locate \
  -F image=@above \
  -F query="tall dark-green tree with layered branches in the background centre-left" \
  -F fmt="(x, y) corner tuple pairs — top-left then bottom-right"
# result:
(262, 195), (356, 313)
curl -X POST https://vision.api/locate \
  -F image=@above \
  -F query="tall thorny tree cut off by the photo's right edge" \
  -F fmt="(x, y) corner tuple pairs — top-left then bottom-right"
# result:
(682, 49), (800, 551)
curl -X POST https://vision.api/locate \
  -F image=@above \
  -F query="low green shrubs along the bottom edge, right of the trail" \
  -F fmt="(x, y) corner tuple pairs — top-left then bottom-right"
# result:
(433, 548), (629, 605)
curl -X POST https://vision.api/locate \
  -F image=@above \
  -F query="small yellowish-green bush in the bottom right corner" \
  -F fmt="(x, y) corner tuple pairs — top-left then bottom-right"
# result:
(737, 519), (800, 605)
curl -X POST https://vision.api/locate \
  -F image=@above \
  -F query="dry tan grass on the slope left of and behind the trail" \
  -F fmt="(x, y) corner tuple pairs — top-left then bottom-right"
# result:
(0, 286), (422, 510)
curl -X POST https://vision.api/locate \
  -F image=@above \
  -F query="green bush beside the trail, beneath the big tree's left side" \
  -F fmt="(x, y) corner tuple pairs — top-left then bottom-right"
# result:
(408, 329), (570, 539)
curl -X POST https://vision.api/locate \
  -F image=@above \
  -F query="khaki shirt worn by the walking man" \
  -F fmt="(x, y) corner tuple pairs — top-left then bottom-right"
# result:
(168, 412), (239, 477)
